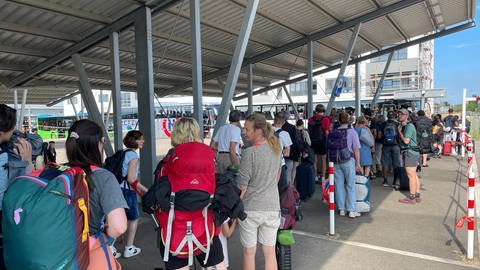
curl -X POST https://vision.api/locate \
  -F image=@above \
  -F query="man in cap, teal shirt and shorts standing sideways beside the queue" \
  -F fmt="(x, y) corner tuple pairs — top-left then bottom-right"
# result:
(397, 109), (421, 204)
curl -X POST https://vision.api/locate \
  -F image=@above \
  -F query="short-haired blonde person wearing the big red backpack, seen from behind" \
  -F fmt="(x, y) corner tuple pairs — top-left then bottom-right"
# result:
(156, 117), (226, 270)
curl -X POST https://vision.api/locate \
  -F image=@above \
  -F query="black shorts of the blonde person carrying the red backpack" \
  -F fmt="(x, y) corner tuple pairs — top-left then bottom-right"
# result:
(160, 236), (223, 270)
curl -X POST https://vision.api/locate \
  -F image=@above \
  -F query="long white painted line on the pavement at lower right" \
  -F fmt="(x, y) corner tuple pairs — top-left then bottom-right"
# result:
(292, 230), (480, 269)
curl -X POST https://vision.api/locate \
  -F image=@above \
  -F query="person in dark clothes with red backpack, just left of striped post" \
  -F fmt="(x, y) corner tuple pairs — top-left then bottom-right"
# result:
(308, 104), (333, 183)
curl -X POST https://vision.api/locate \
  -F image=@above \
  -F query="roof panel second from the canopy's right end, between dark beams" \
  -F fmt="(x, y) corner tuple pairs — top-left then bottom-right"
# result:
(390, 2), (434, 37)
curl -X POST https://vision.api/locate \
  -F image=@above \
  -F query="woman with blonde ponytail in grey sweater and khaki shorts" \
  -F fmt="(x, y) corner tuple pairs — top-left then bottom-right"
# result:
(237, 113), (282, 270)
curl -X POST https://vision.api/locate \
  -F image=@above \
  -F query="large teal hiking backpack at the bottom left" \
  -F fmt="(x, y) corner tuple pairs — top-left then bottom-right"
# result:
(2, 168), (89, 270)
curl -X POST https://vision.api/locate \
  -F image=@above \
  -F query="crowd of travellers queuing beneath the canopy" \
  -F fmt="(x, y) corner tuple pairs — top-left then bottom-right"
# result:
(0, 104), (468, 270)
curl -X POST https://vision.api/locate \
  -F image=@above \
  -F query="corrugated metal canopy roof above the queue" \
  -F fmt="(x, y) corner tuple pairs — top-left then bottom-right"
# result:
(0, 0), (475, 104)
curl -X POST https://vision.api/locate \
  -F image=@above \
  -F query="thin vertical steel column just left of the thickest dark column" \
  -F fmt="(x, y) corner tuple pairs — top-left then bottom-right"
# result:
(110, 32), (123, 151)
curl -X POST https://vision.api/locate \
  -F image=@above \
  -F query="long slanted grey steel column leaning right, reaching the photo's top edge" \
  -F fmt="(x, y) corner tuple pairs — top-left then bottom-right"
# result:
(213, 0), (260, 136)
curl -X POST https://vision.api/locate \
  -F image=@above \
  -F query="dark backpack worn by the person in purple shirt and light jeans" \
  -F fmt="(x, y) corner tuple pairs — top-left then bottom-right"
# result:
(327, 127), (352, 163)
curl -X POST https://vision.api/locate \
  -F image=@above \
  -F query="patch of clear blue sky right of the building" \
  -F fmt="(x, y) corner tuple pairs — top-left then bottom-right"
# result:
(434, 5), (480, 104)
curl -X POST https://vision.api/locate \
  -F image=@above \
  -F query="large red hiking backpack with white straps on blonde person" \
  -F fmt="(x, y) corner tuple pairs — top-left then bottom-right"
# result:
(155, 142), (220, 265)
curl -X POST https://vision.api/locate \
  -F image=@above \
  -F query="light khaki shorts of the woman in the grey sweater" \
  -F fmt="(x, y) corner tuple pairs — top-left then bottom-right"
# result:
(239, 211), (280, 248)
